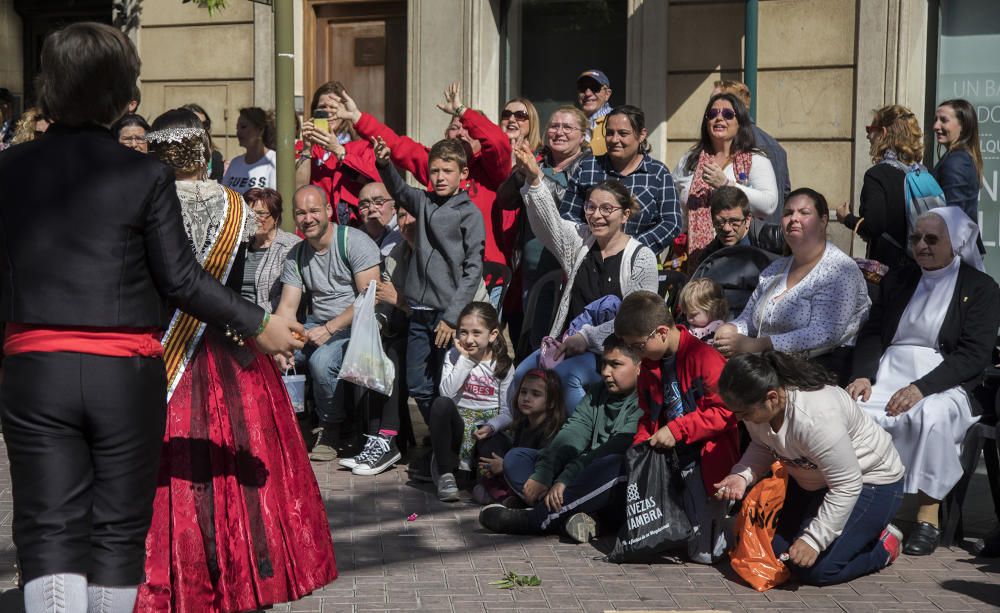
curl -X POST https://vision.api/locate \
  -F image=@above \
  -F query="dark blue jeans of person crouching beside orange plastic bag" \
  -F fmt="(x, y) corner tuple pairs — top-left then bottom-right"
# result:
(771, 478), (903, 585)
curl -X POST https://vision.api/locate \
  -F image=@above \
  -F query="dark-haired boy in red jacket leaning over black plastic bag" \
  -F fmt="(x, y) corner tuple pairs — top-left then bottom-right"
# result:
(615, 291), (740, 564)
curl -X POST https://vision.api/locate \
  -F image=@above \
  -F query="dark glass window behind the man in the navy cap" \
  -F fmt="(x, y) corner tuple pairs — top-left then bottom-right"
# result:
(501, 0), (628, 122)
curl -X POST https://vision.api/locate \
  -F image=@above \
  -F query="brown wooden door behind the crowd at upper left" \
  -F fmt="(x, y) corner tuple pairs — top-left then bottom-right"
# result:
(304, 1), (406, 131)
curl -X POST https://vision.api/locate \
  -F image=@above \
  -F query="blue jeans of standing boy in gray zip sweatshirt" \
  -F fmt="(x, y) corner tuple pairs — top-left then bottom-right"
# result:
(406, 309), (445, 424)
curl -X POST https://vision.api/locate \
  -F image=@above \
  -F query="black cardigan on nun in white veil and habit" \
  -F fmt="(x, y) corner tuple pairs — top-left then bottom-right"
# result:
(850, 262), (1000, 396)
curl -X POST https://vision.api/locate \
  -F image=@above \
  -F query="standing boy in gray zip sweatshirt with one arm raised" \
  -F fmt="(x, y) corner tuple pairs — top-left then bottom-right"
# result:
(372, 137), (486, 421)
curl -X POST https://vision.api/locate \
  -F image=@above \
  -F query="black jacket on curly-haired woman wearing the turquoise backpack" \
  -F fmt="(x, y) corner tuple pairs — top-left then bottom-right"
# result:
(843, 164), (912, 268)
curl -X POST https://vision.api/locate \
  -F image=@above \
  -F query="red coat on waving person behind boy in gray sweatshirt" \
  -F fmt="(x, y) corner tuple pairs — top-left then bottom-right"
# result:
(354, 109), (520, 266)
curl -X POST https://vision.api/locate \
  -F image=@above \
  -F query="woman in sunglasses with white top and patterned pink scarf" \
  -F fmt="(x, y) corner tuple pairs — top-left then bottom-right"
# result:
(674, 93), (778, 261)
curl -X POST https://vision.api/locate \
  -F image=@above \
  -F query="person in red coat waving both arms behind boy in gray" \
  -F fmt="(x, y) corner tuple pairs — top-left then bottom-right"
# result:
(337, 83), (520, 266)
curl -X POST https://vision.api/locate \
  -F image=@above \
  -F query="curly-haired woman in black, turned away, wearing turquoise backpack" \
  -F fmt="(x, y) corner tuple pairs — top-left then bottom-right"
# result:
(837, 104), (924, 268)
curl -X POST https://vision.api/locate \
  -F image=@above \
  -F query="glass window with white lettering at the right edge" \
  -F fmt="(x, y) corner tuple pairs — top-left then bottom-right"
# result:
(927, 0), (1000, 270)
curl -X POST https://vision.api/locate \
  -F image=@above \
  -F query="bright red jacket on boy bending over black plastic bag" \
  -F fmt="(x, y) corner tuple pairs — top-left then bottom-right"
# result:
(632, 326), (740, 495)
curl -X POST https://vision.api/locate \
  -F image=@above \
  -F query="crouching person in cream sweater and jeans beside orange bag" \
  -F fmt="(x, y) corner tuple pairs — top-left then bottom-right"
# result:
(716, 351), (903, 585)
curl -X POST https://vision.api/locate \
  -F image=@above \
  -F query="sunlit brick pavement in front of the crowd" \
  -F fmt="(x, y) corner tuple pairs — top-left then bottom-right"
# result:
(0, 444), (1000, 613)
